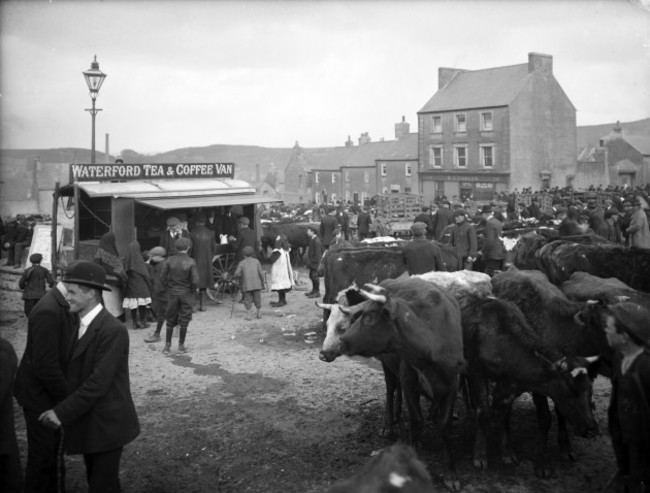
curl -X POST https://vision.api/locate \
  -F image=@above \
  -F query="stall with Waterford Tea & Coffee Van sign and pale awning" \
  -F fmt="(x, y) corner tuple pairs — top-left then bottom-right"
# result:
(57, 163), (278, 262)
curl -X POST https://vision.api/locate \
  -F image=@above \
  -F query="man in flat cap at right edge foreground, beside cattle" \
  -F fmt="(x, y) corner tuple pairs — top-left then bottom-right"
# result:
(605, 302), (650, 493)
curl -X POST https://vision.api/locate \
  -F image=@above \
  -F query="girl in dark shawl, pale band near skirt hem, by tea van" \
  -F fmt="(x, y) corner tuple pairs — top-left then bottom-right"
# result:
(122, 241), (151, 329)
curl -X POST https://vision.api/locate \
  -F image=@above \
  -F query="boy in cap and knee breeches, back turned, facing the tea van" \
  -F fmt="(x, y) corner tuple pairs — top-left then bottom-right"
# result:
(160, 237), (199, 354)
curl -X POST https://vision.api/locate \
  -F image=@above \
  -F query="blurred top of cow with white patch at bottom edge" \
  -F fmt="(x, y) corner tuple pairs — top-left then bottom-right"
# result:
(327, 443), (435, 493)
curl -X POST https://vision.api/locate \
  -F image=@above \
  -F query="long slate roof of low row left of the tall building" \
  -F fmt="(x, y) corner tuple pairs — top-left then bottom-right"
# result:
(302, 133), (418, 170)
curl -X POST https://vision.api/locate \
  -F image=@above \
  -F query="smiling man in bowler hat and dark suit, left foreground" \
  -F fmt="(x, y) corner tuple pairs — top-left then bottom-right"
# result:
(39, 261), (140, 493)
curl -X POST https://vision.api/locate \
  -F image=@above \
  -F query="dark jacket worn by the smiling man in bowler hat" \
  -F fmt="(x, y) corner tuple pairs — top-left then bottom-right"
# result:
(54, 308), (140, 454)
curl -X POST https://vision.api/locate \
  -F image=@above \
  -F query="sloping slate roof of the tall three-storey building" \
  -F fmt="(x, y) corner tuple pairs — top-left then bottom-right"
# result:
(418, 63), (532, 113)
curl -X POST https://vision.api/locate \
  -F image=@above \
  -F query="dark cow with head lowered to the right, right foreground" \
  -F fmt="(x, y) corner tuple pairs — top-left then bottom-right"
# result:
(460, 294), (597, 474)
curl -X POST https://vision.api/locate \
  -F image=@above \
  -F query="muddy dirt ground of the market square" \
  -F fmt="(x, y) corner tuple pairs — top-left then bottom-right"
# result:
(0, 271), (614, 493)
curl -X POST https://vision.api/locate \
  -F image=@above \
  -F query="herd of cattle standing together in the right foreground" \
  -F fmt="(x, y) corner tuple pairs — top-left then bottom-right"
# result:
(306, 232), (650, 491)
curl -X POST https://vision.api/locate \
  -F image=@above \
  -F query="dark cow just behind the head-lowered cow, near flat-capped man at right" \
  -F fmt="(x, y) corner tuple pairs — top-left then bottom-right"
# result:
(492, 269), (612, 477)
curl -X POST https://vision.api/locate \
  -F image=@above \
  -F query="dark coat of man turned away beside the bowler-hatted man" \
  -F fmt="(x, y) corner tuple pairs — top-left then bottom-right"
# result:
(14, 287), (78, 413)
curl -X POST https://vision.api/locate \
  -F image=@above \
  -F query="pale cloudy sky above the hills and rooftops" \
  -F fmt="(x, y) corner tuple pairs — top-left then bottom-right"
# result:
(0, 0), (650, 154)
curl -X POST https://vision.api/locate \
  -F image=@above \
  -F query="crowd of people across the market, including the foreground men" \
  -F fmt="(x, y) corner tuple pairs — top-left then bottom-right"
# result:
(0, 184), (650, 492)
